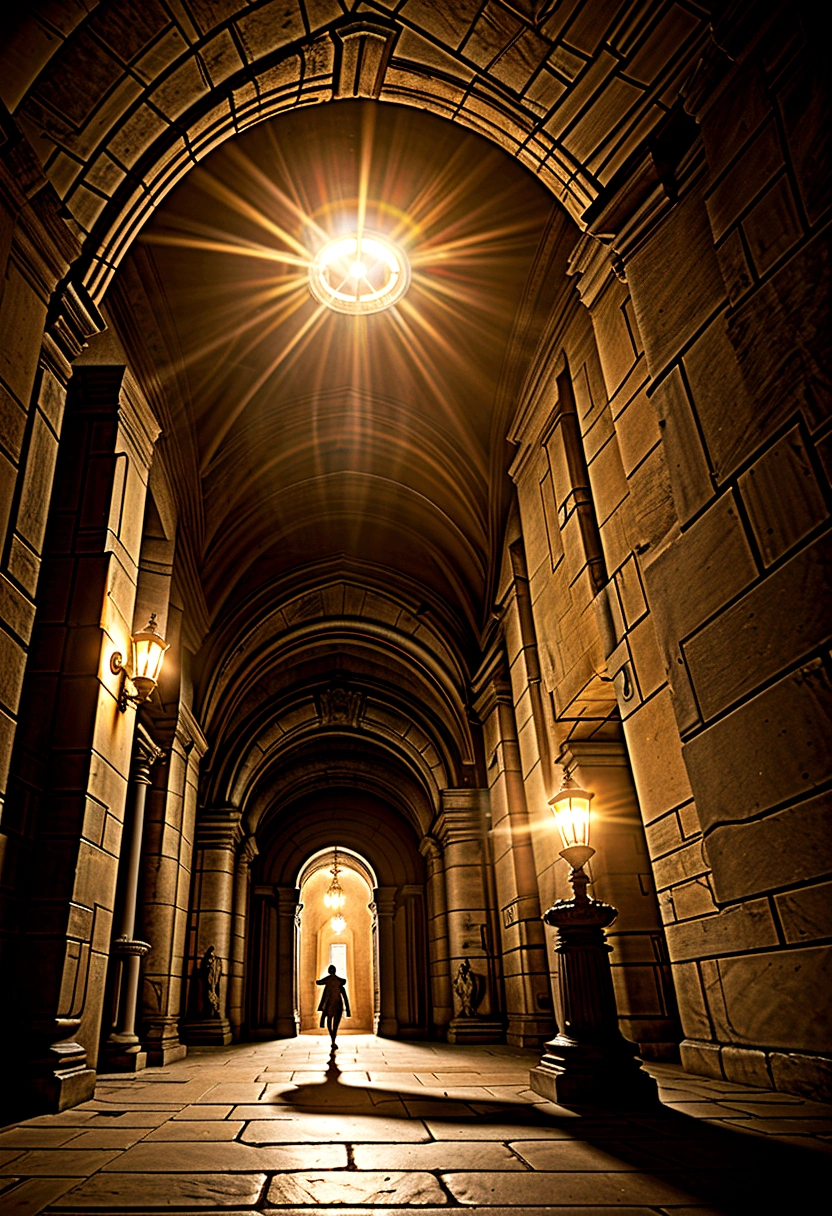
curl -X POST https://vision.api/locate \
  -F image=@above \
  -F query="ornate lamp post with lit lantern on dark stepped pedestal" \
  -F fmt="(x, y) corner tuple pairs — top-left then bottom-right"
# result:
(529, 770), (658, 1105)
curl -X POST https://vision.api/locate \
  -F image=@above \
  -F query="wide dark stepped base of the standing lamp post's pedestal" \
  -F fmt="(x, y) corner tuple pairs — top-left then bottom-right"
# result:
(529, 1035), (659, 1107)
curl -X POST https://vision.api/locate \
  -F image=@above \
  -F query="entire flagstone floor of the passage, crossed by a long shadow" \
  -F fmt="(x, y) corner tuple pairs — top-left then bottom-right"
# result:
(0, 1035), (832, 1216)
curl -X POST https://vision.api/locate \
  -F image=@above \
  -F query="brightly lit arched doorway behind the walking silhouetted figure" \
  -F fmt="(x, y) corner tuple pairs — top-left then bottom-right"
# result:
(296, 848), (376, 1035)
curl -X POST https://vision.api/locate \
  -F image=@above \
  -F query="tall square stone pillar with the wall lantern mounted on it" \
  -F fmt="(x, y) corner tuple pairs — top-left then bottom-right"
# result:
(4, 366), (158, 1109)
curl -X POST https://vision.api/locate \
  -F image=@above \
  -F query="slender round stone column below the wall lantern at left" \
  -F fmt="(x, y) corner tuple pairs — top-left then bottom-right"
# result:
(106, 725), (164, 1073)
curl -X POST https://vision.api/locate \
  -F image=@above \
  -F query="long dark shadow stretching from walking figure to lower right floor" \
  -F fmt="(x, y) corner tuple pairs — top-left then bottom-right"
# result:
(271, 1052), (832, 1216)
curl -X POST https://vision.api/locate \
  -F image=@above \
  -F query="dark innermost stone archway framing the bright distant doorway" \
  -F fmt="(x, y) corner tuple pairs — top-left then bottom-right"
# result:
(247, 787), (428, 1038)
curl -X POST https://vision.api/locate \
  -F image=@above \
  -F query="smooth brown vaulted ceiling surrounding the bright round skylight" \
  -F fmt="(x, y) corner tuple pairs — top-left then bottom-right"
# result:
(112, 101), (577, 653)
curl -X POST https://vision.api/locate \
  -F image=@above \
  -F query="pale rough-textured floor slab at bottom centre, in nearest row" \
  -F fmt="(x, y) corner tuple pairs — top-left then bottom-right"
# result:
(269, 1170), (448, 1206)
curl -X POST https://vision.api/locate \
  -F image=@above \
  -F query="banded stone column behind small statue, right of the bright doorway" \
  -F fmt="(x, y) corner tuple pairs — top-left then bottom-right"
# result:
(433, 789), (504, 1043)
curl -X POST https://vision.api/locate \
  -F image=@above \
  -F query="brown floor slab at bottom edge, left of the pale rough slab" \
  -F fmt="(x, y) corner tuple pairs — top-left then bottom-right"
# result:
(51, 1173), (266, 1216)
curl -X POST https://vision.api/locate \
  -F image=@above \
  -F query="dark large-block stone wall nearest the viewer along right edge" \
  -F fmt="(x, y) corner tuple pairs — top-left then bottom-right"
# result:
(613, 11), (832, 1094)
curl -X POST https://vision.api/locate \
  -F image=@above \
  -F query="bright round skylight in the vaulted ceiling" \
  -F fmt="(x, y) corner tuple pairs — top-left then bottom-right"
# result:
(309, 232), (410, 313)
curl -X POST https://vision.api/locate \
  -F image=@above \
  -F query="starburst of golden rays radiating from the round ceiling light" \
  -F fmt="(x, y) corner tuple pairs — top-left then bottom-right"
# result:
(144, 118), (544, 472)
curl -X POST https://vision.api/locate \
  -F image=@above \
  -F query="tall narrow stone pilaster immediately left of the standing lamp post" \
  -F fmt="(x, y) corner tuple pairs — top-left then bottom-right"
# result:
(474, 648), (555, 1047)
